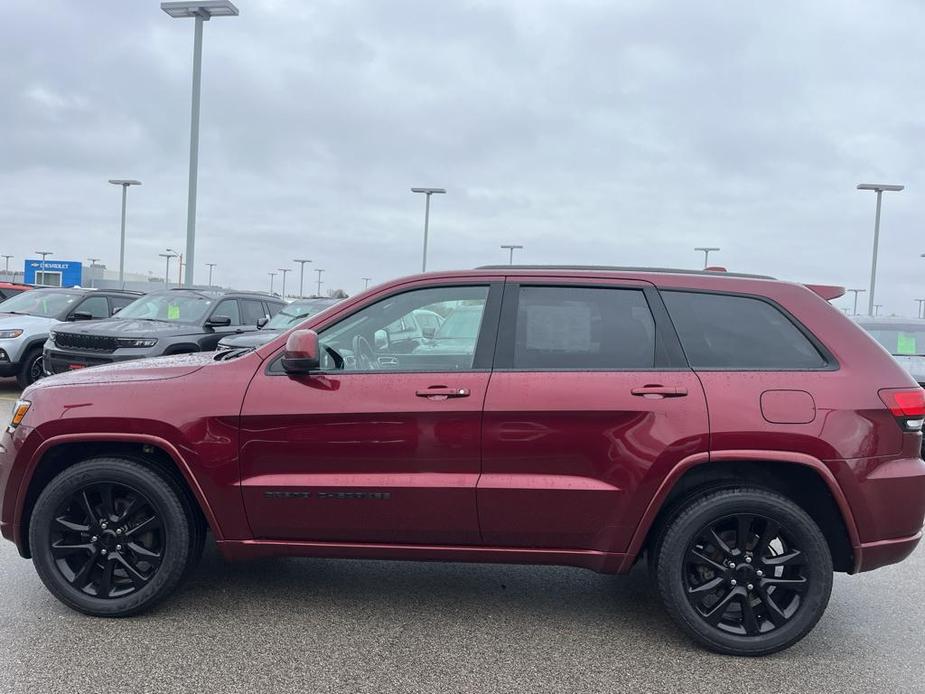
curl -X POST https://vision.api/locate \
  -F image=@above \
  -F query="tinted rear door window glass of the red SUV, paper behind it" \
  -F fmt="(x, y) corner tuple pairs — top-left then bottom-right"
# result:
(508, 287), (655, 370)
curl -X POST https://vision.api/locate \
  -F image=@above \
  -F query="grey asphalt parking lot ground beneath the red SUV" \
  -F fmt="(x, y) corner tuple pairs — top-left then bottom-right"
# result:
(0, 390), (925, 694)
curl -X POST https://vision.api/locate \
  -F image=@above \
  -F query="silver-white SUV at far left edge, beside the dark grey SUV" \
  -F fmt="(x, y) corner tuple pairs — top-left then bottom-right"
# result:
(0, 288), (141, 388)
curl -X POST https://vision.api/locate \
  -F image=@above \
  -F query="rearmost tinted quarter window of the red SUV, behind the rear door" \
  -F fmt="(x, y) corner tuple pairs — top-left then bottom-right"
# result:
(662, 291), (827, 370)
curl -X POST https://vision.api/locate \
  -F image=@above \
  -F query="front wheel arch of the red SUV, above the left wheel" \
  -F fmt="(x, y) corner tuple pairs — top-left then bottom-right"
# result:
(14, 434), (223, 557)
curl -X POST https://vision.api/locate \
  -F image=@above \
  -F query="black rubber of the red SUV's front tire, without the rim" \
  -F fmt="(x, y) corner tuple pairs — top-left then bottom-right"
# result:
(29, 458), (191, 617)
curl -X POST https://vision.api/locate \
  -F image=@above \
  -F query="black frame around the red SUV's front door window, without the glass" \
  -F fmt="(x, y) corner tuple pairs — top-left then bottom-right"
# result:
(264, 280), (504, 379)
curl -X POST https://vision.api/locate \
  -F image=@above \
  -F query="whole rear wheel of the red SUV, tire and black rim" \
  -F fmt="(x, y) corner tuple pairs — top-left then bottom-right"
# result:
(650, 488), (832, 656)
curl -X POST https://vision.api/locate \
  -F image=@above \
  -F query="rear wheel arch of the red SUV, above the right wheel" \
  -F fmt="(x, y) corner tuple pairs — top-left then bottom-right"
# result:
(621, 451), (860, 573)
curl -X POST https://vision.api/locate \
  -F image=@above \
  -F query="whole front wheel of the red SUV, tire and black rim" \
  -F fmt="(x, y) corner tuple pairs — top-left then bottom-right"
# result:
(29, 458), (195, 617)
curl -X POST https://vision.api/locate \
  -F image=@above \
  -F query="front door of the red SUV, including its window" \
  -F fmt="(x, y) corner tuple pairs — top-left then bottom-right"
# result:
(241, 282), (502, 544)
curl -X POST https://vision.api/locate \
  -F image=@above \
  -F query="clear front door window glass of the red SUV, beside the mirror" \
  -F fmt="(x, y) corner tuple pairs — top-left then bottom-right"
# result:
(320, 286), (488, 371)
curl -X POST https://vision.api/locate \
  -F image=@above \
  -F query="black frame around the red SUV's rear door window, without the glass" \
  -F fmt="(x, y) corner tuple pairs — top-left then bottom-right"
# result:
(494, 277), (691, 373)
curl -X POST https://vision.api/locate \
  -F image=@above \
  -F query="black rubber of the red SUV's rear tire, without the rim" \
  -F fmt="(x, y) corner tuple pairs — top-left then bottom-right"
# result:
(655, 490), (833, 656)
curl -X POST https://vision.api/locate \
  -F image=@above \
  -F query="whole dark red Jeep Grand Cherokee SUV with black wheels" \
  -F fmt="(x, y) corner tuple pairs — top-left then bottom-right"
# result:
(0, 266), (925, 655)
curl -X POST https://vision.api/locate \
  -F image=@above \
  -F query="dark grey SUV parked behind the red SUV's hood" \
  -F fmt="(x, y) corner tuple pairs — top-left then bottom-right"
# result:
(44, 289), (286, 374)
